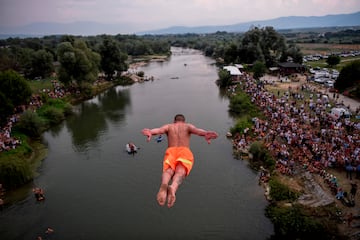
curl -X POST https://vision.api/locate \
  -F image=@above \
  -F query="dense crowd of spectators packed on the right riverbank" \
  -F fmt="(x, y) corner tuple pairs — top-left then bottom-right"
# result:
(229, 72), (360, 198)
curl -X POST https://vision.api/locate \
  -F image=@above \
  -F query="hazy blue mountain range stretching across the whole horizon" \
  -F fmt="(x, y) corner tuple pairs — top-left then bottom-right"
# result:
(0, 12), (360, 38)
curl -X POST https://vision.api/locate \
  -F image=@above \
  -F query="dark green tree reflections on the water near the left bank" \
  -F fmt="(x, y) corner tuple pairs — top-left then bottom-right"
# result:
(66, 88), (131, 151)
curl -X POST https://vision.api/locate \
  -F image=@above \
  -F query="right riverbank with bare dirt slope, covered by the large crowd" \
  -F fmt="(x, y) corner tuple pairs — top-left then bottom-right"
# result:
(234, 72), (360, 239)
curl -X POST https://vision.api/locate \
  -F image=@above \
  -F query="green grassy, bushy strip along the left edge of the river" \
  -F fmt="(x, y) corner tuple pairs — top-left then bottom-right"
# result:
(0, 72), (139, 193)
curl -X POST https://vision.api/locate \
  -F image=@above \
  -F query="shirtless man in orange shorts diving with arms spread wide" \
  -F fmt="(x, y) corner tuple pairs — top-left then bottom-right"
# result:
(142, 114), (218, 208)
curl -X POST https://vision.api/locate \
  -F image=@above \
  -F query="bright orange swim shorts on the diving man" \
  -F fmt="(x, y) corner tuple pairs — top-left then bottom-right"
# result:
(163, 147), (194, 176)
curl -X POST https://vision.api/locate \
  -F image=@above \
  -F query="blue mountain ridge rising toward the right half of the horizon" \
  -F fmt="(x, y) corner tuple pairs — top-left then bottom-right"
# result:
(137, 12), (360, 35)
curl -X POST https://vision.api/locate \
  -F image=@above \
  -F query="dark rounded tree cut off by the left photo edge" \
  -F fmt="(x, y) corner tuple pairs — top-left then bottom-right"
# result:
(0, 70), (31, 123)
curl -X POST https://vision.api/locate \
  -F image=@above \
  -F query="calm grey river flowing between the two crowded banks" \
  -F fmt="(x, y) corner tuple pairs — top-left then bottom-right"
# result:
(0, 48), (273, 240)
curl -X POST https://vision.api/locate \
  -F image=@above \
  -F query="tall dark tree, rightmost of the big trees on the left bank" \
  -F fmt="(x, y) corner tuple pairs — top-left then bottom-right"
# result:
(100, 36), (128, 80)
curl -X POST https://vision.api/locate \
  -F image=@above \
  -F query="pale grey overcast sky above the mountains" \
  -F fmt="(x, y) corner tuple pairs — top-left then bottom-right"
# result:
(0, 0), (360, 33)
